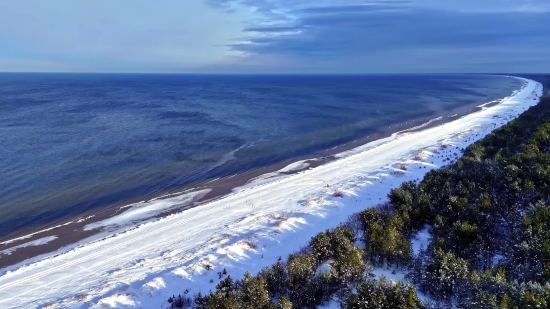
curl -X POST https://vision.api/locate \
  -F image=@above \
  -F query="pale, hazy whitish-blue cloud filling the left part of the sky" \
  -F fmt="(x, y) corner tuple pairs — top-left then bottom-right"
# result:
(0, 0), (250, 72)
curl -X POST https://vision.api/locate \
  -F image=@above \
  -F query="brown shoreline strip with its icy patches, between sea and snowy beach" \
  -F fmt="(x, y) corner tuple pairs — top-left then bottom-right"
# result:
(0, 76), (528, 269)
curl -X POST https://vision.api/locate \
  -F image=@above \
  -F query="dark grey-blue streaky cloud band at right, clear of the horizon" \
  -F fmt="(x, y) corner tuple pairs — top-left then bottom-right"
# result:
(236, 11), (548, 56)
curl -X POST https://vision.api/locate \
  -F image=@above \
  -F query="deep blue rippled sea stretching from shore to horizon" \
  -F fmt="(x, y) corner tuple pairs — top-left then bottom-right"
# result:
(0, 73), (521, 237)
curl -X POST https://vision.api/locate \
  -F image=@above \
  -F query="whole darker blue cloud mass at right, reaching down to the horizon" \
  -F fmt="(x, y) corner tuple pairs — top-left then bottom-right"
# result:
(219, 0), (550, 72)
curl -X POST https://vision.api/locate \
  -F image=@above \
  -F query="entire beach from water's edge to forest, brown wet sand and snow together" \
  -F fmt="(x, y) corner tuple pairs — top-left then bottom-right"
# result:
(0, 76), (543, 308)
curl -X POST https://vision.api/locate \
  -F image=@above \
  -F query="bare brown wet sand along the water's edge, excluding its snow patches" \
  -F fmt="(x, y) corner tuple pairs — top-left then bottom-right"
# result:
(0, 95), (508, 271)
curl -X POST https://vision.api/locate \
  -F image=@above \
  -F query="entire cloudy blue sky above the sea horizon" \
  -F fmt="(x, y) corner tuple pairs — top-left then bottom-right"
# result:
(0, 0), (550, 74)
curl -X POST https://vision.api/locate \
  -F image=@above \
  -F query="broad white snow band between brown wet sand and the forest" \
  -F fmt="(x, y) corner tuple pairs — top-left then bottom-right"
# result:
(0, 80), (542, 308)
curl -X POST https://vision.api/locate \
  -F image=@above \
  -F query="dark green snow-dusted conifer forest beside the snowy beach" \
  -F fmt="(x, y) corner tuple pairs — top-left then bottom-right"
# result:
(168, 76), (550, 309)
